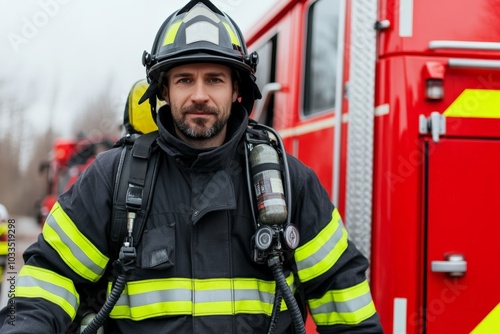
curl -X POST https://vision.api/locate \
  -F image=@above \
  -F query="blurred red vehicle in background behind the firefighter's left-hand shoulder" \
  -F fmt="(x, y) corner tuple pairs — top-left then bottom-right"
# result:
(37, 137), (114, 226)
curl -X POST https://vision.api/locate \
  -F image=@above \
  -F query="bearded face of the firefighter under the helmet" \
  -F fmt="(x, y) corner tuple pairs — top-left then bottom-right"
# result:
(163, 63), (238, 147)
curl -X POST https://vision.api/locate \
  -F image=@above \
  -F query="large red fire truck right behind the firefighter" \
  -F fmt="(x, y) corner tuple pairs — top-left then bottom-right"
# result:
(245, 0), (500, 334)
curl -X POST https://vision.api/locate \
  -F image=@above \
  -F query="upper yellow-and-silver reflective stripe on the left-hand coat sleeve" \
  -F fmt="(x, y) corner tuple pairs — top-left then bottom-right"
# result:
(42, 202), (109, 282)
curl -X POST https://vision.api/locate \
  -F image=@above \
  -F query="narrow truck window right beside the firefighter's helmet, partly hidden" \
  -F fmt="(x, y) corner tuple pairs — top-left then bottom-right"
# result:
(256, 35), (278, 126)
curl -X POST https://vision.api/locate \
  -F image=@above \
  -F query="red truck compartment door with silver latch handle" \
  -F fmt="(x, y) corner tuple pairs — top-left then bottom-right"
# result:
(423, 127), (500, 334)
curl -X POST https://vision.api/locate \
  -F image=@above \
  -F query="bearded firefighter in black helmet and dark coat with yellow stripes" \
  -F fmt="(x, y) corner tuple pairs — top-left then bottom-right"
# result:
(0, 0), (382, 334)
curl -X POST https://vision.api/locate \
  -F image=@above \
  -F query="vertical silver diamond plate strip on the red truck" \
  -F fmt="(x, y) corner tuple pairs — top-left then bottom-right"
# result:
(346, 0), (377, 259)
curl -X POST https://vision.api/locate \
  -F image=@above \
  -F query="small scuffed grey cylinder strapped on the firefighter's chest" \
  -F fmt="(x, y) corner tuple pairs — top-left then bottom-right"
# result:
(249, 144), (287, 225)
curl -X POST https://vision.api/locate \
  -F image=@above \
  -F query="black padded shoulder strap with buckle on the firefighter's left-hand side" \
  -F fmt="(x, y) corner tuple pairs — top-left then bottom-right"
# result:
(110, 131), (160, 257)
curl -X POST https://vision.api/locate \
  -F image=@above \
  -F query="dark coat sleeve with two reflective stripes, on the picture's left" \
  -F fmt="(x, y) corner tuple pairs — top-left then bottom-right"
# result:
(0, 150), (119, 334)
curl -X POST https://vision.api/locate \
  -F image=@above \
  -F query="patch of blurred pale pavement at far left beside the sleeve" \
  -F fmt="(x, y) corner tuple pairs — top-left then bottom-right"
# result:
(0, 216), (41, 308)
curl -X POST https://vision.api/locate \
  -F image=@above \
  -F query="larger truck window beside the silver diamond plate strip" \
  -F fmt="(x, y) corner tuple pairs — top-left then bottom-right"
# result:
(303, 0), (341, 116)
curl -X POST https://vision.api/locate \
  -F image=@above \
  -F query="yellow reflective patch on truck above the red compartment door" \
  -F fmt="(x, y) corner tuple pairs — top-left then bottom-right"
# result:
(443, 89), (500, 118)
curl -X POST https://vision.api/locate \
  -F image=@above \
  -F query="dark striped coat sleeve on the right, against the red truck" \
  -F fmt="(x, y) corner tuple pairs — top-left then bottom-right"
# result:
(289, 158), (382, 333)
